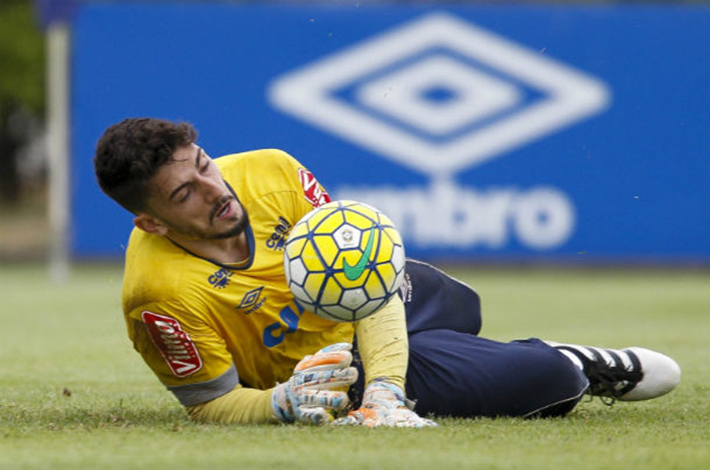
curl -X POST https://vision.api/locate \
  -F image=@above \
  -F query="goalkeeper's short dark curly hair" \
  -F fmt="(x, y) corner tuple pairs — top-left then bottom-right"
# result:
(94, 118), (197, 214)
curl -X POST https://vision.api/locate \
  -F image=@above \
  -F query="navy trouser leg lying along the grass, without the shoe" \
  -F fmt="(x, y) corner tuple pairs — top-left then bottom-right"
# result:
(407, 330), (589, 417)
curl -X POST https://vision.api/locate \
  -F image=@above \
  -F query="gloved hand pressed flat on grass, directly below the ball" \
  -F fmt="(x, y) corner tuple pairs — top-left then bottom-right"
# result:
(333, 381), (438, 428)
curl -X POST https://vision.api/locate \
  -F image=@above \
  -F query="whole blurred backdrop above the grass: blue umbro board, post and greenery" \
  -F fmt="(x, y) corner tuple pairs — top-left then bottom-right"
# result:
(0, 0), (710, 278)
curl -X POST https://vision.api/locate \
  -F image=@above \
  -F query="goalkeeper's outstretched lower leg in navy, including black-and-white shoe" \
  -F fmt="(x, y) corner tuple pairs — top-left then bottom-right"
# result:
(407, 330), (681, 417)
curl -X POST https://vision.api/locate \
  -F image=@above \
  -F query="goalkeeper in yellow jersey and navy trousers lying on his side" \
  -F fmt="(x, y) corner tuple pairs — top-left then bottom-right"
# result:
(94, 118), (680, 427)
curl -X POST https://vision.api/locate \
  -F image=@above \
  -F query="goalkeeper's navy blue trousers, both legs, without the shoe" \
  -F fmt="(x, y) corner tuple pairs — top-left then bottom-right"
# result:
(351, 260), (589, 417)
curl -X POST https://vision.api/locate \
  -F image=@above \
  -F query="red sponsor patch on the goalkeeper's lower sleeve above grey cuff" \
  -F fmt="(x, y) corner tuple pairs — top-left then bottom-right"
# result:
(141, 310), (202, 377)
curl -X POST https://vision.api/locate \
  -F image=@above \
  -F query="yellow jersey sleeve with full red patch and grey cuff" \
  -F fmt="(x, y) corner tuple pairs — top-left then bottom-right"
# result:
(127, 302), (239, 406)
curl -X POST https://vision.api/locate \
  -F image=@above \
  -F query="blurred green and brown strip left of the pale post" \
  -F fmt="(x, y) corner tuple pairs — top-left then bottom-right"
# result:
(0, 0), (48, 260)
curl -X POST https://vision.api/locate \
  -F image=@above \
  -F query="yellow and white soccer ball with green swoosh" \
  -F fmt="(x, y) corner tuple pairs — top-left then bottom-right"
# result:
(284, 201), (404, 322)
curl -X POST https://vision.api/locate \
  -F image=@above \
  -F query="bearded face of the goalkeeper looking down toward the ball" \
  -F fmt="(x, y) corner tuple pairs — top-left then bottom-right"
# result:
(140, 144), (248, 239)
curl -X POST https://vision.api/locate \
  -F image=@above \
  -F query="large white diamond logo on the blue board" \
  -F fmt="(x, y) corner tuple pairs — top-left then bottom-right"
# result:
(269, 13), (610, 177)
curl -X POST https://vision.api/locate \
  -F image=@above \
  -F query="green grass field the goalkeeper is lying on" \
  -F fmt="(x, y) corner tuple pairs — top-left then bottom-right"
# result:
(0, 265), (710, 470)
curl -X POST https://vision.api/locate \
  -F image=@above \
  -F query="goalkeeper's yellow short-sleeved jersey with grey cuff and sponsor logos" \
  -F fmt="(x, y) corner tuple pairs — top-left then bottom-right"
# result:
(123, 150), (354, 406)
